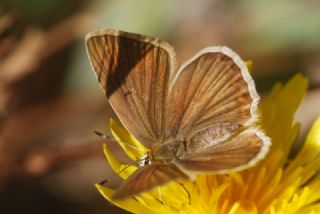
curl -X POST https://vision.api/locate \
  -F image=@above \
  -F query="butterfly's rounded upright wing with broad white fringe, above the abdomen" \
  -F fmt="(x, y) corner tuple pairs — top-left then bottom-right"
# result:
(167, 47), (259, 139)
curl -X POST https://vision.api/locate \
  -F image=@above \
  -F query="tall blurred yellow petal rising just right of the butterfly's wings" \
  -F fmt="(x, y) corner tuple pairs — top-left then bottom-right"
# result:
(260, 74), (308, 166)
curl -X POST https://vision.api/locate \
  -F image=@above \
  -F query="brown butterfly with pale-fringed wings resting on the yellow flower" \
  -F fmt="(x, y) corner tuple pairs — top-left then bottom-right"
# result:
(86, 29), (270, 199)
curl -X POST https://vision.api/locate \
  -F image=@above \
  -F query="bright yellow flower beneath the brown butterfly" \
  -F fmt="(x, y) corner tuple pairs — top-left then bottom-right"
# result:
(96, 75), (320, 214)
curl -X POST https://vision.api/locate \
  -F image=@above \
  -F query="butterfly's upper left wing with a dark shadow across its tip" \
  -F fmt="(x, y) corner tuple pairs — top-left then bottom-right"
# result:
(86, 30), (175, 146)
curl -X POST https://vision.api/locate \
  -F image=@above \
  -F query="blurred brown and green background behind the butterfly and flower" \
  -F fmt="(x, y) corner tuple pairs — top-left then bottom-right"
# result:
(0, 0), (320, 214)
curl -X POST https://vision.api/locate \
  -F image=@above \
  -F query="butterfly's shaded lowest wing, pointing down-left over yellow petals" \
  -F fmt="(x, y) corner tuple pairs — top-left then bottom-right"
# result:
(112, 164), (188, 199)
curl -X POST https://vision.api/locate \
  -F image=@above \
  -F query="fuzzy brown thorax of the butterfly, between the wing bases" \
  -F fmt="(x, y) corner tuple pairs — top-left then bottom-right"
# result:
(150, 140), (187, 163)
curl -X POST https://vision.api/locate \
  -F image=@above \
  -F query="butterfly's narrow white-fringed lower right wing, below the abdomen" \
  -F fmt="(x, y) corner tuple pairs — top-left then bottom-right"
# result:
(177, 128), (270, 173)
